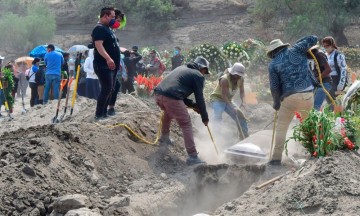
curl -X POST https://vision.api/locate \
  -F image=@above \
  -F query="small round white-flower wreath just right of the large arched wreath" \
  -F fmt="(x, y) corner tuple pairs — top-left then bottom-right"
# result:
(222, 42), (250, 65)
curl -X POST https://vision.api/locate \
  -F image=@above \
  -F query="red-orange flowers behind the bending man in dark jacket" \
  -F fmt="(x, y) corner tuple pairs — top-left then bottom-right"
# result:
(134, 75), (161, 97)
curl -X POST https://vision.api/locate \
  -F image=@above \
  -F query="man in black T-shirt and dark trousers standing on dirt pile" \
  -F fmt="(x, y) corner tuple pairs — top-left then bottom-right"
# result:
(91, 7), (120, 119)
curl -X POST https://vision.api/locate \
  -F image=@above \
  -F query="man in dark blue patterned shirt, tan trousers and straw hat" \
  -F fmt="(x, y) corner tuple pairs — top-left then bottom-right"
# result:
(267, 36), (318, 165)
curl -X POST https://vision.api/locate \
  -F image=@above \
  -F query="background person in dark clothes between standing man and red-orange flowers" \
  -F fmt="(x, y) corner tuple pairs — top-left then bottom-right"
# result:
(121, 50), (142, 94)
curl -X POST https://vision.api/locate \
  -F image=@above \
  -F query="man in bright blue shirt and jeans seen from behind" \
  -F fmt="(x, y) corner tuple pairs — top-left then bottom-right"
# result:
(44, 44), (64, 104)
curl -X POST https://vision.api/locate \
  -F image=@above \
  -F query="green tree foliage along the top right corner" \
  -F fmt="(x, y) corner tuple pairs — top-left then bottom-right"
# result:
(253, 0), (360, 45)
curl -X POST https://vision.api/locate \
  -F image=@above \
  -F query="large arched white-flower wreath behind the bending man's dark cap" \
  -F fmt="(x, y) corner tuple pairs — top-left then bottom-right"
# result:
(187, 44), (229, 74)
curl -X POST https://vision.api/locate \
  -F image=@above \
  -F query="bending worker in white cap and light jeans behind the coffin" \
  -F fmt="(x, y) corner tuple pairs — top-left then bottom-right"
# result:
(210, 63), (249, 139)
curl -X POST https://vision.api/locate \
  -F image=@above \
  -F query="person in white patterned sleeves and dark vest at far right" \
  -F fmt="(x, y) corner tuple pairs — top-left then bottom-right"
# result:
(321, 36), (347, 103)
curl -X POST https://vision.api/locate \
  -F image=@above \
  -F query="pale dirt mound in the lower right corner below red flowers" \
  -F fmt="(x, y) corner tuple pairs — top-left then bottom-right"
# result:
(215, 152), (360, 215)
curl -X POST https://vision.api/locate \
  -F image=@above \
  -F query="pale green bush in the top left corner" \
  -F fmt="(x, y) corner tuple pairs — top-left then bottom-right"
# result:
(0, 2), (56, 53)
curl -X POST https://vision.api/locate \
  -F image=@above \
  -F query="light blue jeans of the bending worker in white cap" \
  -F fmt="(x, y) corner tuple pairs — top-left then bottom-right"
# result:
(211, 101), (249, 137)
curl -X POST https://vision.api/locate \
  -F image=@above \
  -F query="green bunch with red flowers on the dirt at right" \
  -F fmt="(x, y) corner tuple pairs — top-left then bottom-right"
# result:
(285, 107), (360, 157)
